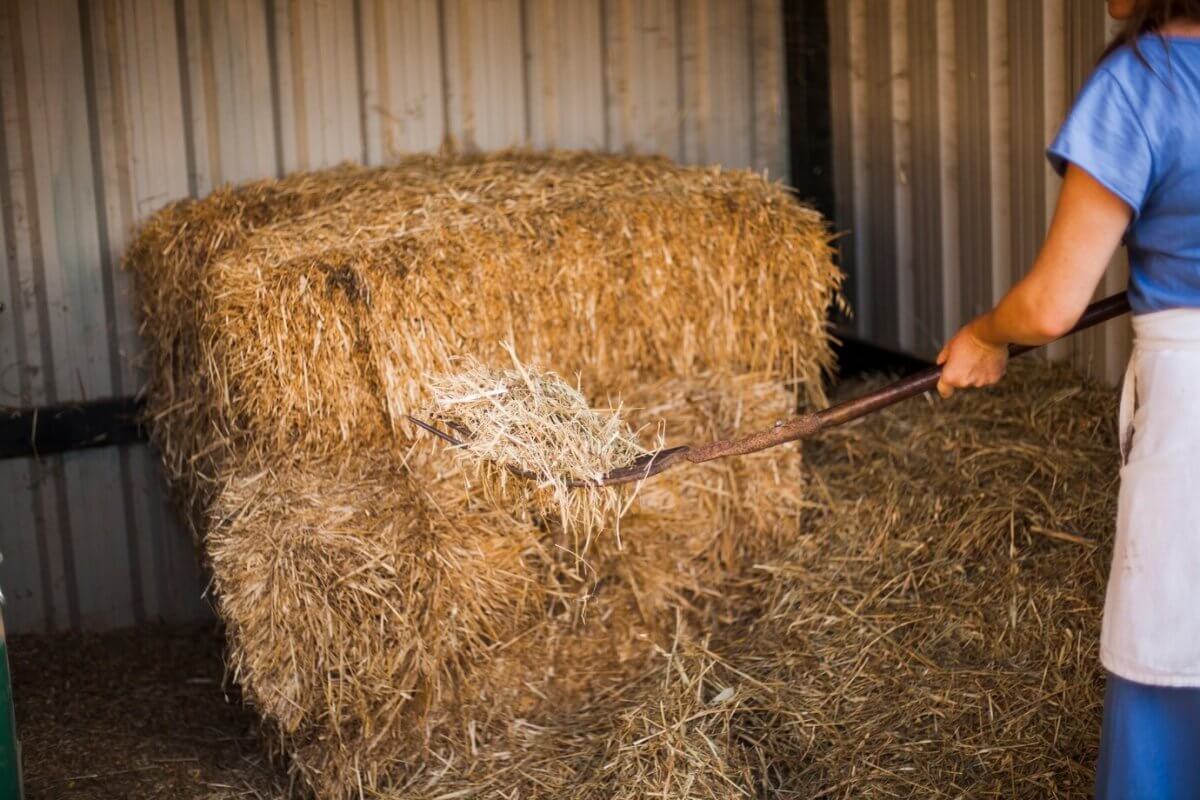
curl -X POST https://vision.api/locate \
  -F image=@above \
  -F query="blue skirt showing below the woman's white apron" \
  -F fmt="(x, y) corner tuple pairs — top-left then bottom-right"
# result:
(1096, 673), (1200, 800)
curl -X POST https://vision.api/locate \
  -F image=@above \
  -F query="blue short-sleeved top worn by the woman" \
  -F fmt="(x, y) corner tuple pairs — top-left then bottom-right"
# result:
(1046, 35), (1200, 314)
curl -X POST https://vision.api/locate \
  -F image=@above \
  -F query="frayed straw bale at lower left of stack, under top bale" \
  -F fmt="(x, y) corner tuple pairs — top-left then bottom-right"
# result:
(206, 456), (548, 796)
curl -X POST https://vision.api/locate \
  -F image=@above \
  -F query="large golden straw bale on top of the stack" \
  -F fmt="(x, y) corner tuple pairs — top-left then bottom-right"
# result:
(128, 154), (839, 522)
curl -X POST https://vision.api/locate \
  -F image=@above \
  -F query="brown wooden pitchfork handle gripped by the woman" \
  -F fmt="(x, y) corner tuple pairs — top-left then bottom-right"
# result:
(684, 291), (1129, 464)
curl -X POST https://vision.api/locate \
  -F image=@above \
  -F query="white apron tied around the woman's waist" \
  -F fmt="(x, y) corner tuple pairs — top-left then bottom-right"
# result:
(1100, 308), (1200, 686)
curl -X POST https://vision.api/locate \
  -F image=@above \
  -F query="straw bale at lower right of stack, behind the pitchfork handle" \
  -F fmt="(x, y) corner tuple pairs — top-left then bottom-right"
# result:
(564, 373), (805, 625)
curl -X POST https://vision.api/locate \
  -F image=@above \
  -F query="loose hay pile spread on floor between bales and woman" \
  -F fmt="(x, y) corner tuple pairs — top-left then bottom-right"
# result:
(391, 363), (1118, 800)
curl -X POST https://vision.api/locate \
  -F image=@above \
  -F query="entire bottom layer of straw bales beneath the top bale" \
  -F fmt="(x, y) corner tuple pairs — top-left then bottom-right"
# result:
(206, 374), (802, 796)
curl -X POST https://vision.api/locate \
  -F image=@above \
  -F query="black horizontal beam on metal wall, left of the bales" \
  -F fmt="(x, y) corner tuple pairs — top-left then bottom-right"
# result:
(0, 397), (146, 458)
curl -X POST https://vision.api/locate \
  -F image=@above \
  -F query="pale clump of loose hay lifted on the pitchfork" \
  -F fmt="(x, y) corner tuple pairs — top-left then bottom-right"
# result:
(428, 347), (662, 557)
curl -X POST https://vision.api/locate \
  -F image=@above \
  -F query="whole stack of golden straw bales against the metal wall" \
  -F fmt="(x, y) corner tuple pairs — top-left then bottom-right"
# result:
(128, 154), (838, 798)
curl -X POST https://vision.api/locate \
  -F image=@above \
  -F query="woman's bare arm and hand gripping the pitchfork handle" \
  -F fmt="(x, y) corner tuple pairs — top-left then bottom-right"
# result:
(937, 164), (1133, 397)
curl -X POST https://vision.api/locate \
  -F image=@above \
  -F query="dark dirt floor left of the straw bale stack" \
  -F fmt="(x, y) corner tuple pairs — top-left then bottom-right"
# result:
(8, 624), (284, 800)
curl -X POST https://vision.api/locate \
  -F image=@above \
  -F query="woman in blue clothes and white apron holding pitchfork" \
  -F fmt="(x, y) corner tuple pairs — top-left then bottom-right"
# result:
(938, 0), (1200, 800)
